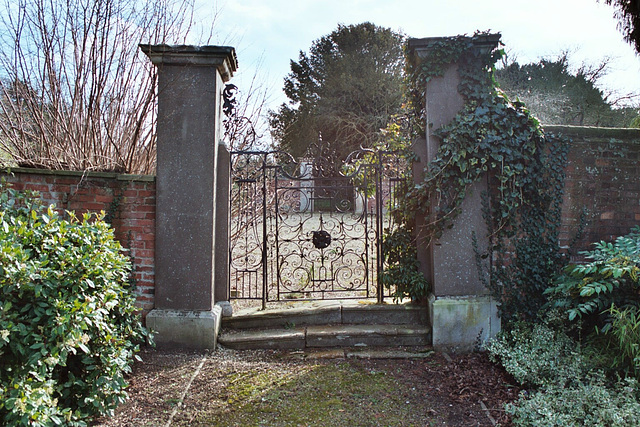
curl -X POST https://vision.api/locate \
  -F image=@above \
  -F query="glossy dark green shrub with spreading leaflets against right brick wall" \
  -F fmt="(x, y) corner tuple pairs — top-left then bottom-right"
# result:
(545, 226), (640, 322)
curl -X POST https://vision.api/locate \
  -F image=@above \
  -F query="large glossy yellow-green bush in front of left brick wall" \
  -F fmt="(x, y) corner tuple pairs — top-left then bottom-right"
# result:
(0, 185), (146, 426)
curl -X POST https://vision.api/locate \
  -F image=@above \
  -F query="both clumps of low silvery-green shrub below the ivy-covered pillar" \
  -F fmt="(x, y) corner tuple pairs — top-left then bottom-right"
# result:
(487, 323), (640, 427)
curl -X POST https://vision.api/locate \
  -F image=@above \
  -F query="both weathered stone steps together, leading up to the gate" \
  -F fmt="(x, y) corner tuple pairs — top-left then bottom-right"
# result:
(220, 301), (431, 349)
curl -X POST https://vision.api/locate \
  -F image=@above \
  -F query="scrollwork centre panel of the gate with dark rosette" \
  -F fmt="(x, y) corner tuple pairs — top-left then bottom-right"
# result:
(276, 160), (375, 298)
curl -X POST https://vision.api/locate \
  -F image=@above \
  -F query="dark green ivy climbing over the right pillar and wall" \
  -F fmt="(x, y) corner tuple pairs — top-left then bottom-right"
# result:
(387, 33), (568, 319)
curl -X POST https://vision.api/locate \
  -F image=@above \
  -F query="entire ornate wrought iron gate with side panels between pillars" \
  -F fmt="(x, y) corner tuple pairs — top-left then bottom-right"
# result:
(229, 150), (407, 306)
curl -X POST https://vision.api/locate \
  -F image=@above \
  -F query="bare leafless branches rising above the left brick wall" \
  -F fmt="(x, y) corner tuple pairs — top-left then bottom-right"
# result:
(0, 0), (213, 174)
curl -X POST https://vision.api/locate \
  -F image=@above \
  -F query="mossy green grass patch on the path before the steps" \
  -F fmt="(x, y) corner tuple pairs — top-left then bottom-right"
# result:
(185, 361), (436, 426)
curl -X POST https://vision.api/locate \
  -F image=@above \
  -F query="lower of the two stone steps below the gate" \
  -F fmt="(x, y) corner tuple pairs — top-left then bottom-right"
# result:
(218, 325), (431, 350)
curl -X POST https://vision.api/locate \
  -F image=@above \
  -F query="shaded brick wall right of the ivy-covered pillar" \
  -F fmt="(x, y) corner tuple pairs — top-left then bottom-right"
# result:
(546, 126), (640, 256)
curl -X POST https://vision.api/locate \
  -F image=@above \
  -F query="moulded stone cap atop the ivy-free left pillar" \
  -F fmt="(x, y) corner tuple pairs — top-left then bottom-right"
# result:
(139, 44), (238, 82)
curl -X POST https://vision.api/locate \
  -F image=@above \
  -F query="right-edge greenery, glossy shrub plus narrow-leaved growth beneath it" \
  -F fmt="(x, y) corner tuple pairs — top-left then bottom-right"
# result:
(545, 227), (640, 378)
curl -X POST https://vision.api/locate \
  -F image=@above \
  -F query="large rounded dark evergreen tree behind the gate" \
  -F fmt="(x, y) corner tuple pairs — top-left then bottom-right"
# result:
(270, 22), (404, 166)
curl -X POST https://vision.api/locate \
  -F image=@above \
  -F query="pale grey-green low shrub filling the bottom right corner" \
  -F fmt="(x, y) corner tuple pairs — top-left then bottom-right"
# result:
(506, 375), (640, 427)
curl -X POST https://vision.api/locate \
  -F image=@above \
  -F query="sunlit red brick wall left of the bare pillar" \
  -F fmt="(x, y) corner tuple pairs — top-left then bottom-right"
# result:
(2, 168), (156, 316)
